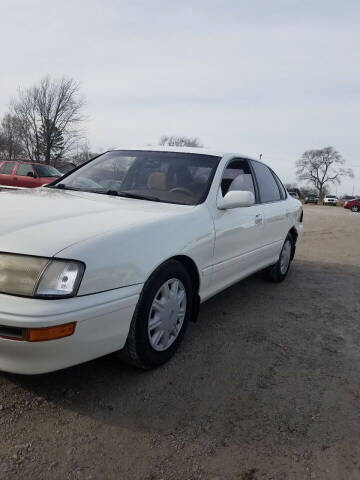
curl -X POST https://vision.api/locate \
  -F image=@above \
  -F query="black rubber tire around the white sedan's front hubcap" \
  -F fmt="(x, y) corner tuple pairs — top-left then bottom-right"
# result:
(118, 260), (194, 370)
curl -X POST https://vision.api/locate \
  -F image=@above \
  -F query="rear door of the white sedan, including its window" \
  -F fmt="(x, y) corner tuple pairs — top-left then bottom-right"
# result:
(251, 160), (292, 263)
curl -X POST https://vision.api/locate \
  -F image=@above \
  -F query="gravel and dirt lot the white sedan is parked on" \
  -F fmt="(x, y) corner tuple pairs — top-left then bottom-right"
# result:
(0, 206), (360, 480)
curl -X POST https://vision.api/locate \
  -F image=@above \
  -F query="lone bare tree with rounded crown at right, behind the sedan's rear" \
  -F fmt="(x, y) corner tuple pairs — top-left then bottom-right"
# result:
(296, 147), (354, 199)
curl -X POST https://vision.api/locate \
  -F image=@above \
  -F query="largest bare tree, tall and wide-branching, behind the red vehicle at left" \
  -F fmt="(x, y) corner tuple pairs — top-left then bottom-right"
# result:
(11, 77), (84, 164)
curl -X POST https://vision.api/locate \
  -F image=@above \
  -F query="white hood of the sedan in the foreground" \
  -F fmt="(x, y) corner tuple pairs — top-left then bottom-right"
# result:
(0, 188), (193, 257)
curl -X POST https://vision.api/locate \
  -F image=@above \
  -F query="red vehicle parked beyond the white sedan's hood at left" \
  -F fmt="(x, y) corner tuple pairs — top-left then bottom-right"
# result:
(0, 161), (62, 188)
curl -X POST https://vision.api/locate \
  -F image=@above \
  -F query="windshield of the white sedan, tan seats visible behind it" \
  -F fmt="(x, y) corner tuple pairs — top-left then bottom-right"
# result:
(54, 150), (220, 205)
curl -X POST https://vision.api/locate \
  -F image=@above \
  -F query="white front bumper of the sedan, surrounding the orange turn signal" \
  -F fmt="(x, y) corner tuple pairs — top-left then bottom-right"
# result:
(0, 285), (142, 374)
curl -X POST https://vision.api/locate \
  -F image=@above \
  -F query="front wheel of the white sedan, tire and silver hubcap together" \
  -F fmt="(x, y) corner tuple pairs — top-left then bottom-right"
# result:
(119, 260), (193, 369)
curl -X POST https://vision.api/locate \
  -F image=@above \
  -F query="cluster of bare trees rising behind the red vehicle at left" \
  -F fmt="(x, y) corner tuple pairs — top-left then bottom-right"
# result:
(0, 77), (91, 165)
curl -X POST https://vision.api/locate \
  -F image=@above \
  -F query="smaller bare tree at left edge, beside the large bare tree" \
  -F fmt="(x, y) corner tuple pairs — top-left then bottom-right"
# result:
(0, 113), (23, 160)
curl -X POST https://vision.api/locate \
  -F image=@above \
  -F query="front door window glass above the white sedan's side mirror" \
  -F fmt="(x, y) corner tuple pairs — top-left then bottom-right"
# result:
(221, 160), (255, 196)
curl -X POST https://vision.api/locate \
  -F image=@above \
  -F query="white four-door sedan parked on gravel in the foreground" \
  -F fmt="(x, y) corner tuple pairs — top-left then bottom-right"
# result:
(0, 148), (303, 374)
